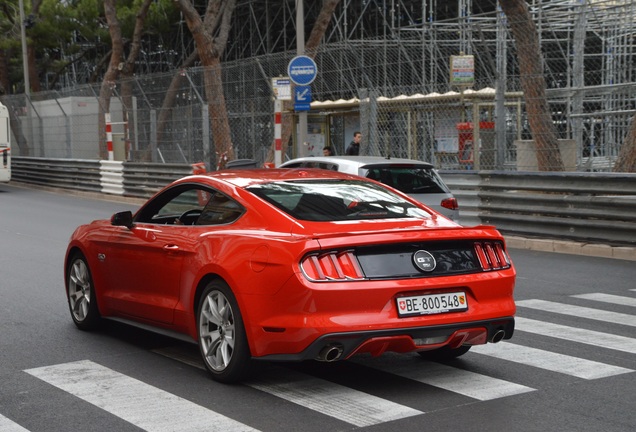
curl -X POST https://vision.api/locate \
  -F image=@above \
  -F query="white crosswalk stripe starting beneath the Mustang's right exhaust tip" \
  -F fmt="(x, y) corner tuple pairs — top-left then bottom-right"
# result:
(471, 342), (633, 380)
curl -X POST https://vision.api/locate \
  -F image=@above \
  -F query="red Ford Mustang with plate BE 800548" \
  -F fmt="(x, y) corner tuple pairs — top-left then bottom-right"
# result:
(65, 169), (515, 382)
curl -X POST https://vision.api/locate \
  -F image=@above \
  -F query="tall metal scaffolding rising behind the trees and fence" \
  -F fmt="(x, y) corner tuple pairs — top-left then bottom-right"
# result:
(9, 0), (636, 170)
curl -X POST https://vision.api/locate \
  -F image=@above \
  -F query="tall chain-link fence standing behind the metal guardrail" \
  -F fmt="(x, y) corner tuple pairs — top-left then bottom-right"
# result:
(2, 0), (636, 171)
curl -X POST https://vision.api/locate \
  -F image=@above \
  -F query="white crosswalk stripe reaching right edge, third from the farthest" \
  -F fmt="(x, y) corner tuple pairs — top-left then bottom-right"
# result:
(513, 317), (636, 354)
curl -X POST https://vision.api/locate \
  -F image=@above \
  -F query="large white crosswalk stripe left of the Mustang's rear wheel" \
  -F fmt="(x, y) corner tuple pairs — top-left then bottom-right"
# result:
(25, 360), (257, 432)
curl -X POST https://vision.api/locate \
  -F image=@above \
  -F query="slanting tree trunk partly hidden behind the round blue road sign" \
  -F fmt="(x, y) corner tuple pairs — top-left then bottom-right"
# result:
(266, 0), (340, 162)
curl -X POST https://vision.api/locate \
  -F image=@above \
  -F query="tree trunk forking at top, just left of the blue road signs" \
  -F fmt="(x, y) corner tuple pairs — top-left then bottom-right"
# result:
(176, 0), (236, 168)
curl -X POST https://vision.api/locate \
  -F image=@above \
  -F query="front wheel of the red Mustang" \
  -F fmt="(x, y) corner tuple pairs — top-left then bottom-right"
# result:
(66, 252), (101, 330)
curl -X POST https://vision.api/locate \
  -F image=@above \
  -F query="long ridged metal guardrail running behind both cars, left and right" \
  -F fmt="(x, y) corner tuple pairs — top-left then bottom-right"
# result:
(12, 156), (636, 245)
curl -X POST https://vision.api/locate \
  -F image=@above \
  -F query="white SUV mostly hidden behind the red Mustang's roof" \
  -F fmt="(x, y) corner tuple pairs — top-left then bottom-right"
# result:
(280, 156), (459, 223)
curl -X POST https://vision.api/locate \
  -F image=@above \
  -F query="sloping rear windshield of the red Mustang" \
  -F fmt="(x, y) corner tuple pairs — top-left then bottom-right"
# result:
(247, 180), (431, 221)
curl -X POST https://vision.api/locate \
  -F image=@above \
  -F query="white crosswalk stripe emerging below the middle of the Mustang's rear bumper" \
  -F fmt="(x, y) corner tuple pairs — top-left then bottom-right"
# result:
(356, 361), (535, 401)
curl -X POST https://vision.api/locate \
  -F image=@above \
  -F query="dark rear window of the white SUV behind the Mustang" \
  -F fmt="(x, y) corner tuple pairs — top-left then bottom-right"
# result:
(360, 166), (449, 194)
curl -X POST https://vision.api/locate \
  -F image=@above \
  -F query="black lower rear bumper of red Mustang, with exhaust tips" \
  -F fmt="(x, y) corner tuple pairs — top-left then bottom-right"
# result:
(255, 317), (515, 361)
